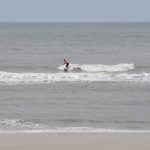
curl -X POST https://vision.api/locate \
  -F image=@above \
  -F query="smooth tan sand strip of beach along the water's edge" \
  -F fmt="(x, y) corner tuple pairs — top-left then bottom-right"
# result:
(0, 133), (150, 150)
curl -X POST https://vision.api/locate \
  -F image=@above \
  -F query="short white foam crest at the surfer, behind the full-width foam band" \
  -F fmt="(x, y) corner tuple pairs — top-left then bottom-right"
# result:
(58, 64), (134, 72)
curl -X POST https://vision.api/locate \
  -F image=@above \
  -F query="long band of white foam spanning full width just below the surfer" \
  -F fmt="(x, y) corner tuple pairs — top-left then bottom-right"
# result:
(0, 72), (150, 84)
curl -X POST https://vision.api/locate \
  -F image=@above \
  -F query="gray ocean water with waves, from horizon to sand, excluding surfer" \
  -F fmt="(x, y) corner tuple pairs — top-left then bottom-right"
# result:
(0, 23), (150, 133)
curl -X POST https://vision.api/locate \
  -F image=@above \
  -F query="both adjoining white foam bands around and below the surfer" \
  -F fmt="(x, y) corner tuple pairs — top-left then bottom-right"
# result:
(0, 64), (150, 84)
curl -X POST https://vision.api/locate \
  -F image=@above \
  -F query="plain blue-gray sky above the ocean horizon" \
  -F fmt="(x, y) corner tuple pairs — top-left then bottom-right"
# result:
(0, 0), (150, 22)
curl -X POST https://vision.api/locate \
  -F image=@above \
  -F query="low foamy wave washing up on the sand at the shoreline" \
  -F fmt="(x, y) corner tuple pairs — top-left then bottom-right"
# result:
(0, 119), (150, 134)
